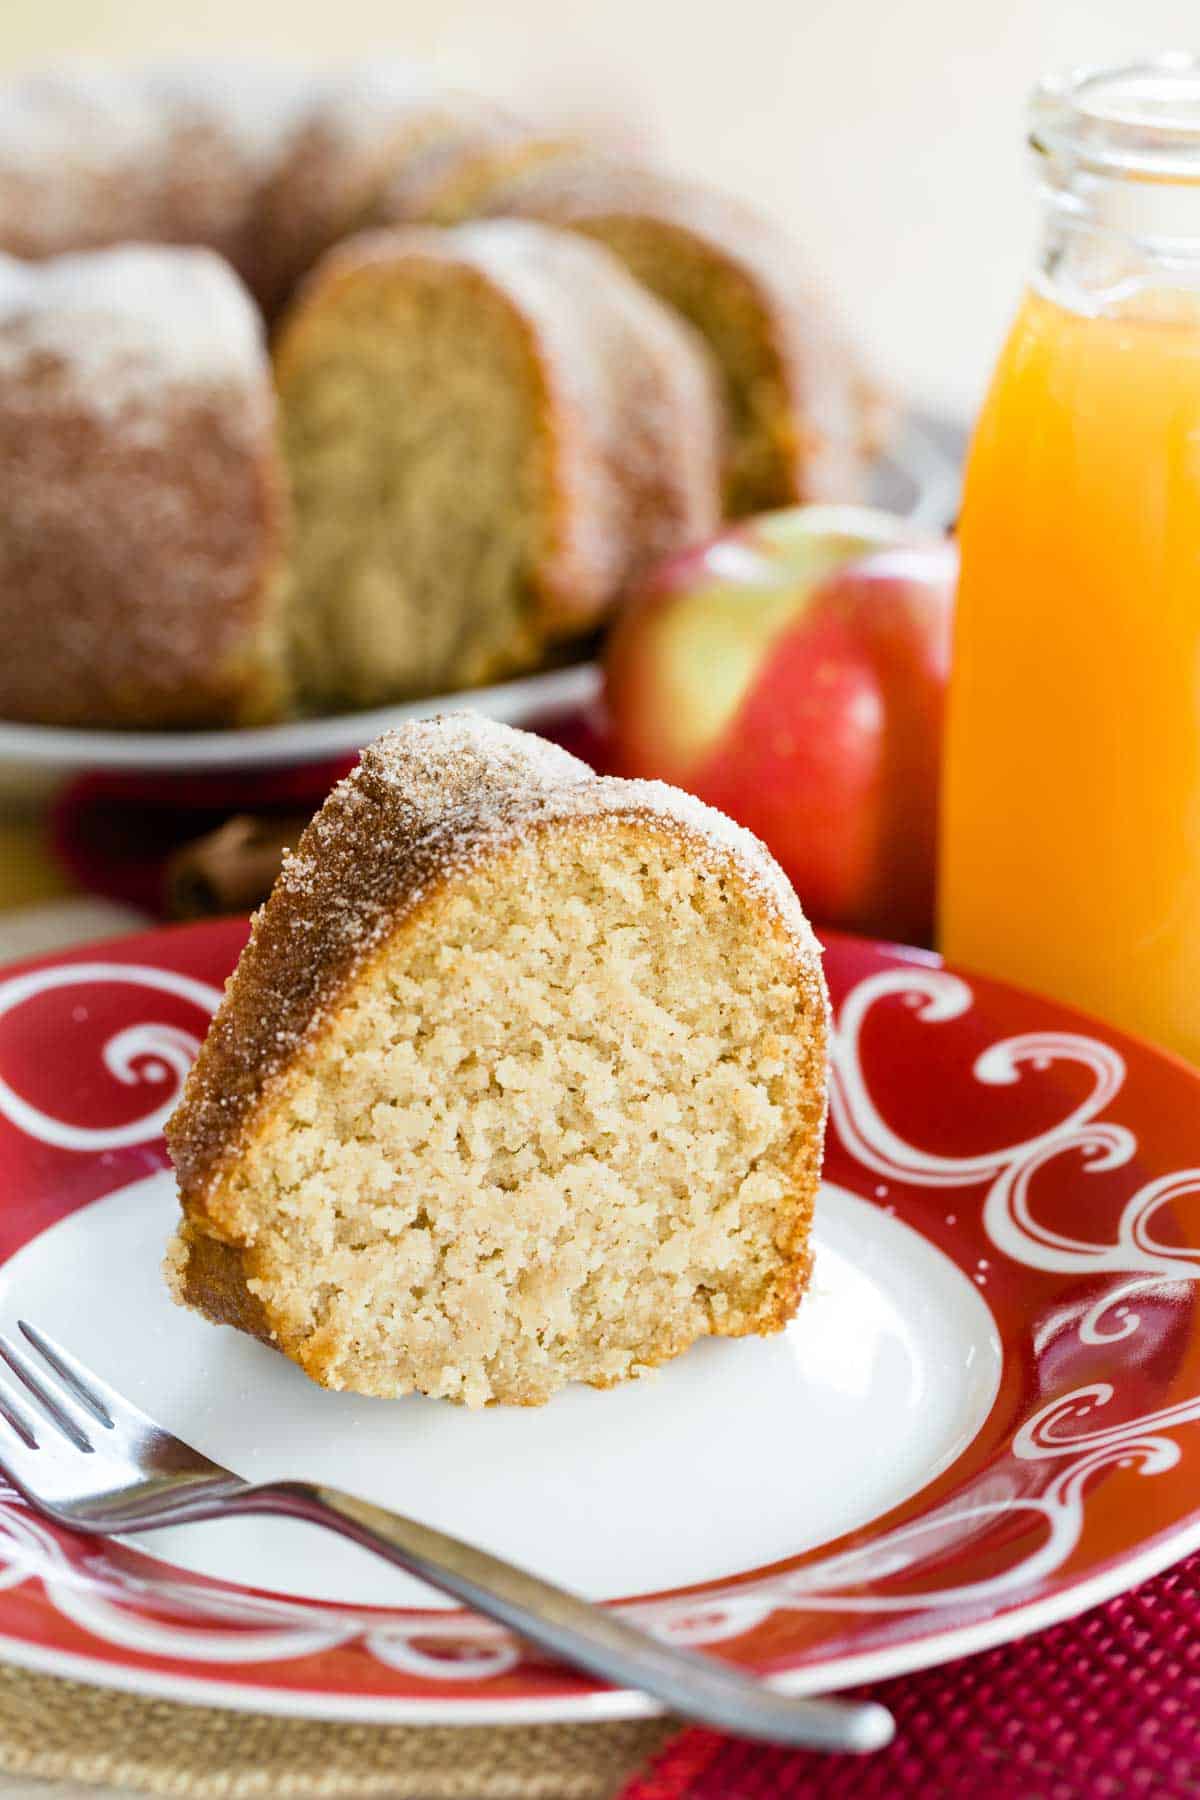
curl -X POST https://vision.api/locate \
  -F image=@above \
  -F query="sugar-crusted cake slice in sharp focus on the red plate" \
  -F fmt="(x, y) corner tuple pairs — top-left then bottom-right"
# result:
(167, 716), (826, 1406)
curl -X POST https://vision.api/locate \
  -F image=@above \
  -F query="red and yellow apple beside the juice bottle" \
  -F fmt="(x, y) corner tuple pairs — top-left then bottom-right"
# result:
(606, 506), (957, 941)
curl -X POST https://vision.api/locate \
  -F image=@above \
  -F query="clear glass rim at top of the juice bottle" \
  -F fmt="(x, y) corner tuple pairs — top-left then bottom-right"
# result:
(1029, 50), (1200, 182)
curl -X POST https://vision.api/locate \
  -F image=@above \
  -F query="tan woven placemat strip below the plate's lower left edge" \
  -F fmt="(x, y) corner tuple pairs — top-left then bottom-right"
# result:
(0, 1665), (678, 1800)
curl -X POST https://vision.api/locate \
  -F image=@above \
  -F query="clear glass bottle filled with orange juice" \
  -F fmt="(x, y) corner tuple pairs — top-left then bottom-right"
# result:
(939, 58), (1200, 1062)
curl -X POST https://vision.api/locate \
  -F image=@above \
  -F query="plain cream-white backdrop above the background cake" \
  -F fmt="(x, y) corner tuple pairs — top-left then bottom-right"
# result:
(0, 0), (1200, 412)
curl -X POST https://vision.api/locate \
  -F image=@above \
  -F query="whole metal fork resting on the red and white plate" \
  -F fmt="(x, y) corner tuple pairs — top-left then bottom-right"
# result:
(0, 1319), (892, 1751)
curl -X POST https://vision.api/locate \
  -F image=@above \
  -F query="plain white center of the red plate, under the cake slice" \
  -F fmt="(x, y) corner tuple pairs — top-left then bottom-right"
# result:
(0, 1174), (1002, 1606)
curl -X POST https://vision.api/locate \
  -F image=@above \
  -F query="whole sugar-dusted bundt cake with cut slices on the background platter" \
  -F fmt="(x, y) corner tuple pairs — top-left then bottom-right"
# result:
(0, 63), (881, 729)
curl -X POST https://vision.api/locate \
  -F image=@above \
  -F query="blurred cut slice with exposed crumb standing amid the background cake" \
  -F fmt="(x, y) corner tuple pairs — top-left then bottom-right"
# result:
(275, 230), (720, 707)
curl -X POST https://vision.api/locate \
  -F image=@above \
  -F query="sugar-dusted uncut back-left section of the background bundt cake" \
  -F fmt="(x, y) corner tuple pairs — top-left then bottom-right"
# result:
(0, 58), (486, 310)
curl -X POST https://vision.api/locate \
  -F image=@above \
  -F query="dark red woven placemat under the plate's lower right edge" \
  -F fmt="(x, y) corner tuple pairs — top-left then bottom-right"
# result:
(621, 1555), (1200, 1800)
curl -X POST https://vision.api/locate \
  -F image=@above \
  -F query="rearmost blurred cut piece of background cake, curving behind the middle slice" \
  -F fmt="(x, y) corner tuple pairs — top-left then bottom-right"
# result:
(460, 153), (876, 517)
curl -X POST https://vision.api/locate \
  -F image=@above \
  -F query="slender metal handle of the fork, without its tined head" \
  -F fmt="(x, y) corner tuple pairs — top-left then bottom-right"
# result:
(230, 1481), (894, 1751)
